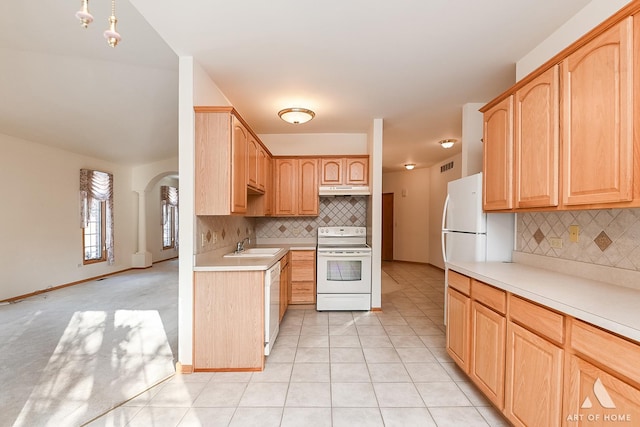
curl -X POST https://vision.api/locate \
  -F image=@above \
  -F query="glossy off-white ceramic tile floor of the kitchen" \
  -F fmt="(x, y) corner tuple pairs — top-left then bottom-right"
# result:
(90, 263), (509, 427)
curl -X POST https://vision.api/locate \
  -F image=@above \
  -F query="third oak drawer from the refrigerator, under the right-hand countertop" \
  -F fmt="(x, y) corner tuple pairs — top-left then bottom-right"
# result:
(509, 294), (564, 344)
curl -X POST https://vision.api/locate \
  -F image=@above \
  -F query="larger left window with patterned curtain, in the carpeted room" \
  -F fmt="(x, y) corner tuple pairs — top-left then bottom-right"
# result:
(80, 169), (114, 264)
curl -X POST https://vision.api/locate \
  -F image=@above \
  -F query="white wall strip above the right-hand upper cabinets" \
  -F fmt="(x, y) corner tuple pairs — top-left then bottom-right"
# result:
(516, 0), (630, 81)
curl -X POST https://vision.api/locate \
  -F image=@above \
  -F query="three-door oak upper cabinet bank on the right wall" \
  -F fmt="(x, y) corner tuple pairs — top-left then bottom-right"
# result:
(481, 5), (640, 211)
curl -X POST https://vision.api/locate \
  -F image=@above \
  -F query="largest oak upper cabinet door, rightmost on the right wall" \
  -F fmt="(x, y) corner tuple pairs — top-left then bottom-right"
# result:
(562, 17), (637, 205)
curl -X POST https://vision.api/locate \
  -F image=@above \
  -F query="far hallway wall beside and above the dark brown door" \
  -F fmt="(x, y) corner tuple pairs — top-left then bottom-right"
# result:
(382, 168), (432, 263)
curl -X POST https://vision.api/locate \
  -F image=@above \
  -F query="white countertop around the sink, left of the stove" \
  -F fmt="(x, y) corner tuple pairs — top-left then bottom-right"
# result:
(193, 243), (316, 271)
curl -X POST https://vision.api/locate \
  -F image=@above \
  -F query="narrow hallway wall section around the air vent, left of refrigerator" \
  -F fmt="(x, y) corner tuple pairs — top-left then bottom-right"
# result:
(429, 154), (463, 269)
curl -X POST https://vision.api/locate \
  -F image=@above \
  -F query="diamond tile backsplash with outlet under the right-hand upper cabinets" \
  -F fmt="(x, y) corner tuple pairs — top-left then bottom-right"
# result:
(517, 208), (640, 271)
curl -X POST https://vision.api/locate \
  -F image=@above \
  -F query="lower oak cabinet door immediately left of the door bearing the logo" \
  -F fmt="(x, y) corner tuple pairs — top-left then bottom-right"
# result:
(505, 322), (564, 427)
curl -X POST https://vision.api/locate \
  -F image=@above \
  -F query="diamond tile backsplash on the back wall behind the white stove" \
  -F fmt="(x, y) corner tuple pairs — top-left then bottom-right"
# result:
(256, 196), (367, 239)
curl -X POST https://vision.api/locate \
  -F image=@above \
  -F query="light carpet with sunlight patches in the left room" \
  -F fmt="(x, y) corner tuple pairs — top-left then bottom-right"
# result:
(0, 260), (178, 427)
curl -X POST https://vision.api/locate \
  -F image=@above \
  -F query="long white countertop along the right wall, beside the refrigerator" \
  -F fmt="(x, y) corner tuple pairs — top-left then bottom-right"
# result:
(447, 262), (640, 342)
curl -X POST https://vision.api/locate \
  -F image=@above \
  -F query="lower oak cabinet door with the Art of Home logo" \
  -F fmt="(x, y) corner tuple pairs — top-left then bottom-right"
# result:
(563, 355), (640, 427)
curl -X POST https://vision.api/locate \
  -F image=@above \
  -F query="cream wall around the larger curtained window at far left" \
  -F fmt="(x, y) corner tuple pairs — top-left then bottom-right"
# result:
(0, 134), (137, 300)
